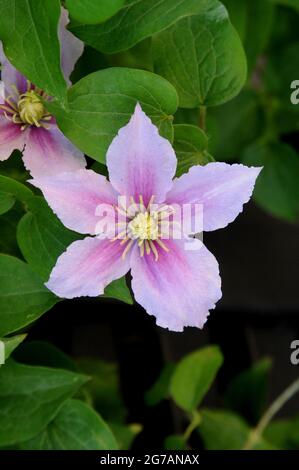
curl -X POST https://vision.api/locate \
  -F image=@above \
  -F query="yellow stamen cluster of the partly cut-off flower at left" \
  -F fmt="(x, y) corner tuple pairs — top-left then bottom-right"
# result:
(0, 81), (51, 130)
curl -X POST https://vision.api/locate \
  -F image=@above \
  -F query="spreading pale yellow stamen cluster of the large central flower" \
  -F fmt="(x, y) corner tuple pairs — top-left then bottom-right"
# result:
(111, 196), (171, 261)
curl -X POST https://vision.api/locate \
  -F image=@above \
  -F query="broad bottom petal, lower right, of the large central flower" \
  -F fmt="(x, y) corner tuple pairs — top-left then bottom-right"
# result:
(131, 240), (221, 331)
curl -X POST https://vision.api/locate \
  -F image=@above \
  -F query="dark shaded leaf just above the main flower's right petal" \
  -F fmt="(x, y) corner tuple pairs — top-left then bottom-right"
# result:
(207, 89), (265, 161)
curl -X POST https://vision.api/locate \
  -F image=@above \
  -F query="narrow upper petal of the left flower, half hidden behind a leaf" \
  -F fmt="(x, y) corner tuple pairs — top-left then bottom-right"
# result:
(58, 8), (84, 85)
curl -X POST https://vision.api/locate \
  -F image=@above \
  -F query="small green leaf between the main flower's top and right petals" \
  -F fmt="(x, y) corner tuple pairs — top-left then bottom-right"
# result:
(173, 124), (214, 176)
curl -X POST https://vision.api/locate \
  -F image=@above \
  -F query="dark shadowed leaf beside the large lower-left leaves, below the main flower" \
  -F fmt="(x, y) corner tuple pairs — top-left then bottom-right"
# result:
(77, 358), (126, 423)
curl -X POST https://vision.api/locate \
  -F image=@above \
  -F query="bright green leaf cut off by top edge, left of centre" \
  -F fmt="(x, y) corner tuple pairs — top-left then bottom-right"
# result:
(66, 0), (125, 24)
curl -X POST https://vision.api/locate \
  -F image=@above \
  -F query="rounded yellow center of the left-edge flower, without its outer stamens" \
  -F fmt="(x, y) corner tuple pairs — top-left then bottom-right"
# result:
(18, 90), (47, 127)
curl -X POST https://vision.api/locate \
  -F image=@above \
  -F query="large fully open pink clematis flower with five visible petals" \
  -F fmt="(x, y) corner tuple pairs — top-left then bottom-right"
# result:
(31, 105), (260, 331)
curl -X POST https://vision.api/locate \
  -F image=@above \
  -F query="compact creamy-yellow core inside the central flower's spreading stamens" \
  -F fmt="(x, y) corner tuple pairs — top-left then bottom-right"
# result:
(128, 211), (159, 240)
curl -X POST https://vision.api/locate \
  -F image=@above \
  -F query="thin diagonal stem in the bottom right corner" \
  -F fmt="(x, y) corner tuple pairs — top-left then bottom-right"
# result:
(243, 379), (299, 450)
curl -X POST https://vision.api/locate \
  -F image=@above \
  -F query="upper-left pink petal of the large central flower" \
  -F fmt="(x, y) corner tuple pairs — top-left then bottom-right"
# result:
(30, 170), (117, 235)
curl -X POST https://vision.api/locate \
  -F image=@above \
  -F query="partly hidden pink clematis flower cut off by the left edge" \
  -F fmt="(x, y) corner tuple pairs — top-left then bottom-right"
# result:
(0, 9), (86, 176)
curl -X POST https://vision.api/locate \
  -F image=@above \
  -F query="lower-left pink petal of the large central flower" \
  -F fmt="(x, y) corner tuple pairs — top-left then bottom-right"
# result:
(46, 237), (130, 299)
